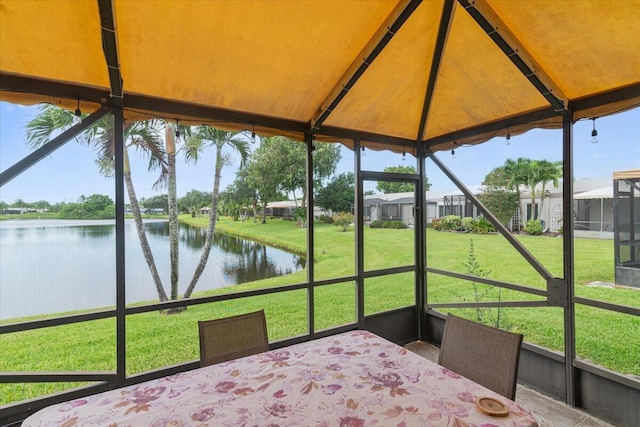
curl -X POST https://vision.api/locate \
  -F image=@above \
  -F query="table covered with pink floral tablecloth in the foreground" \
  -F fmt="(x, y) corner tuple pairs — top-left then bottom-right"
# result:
(23, 331), (537, 427)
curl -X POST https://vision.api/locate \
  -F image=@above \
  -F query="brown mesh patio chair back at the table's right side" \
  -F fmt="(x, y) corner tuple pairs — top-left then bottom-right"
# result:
(438, 314), (523, 400)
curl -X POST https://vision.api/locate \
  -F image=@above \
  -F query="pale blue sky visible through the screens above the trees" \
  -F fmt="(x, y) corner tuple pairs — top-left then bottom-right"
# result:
(0, 102), (640, 203)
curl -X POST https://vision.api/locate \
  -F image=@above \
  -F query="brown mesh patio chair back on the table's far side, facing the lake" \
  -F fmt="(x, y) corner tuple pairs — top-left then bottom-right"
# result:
(198, 310), (269, 366)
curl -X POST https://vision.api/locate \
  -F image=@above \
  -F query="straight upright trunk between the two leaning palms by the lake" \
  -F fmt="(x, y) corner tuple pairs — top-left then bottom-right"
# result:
(165, 124), (179, 301)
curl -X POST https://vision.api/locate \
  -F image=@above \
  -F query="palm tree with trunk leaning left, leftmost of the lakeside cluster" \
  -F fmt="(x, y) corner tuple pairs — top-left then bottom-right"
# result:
(26, 104), (168, 301)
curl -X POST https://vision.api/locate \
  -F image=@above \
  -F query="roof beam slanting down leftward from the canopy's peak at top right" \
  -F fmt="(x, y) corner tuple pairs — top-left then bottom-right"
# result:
(310, 0), (422, 133)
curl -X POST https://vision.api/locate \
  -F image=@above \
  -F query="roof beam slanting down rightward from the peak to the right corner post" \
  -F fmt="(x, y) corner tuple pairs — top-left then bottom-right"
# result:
(458, 0), (569, 116)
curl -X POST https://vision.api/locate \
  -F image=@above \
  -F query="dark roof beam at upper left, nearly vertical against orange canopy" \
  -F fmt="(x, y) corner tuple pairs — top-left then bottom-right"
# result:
(98, 0), (124, 108)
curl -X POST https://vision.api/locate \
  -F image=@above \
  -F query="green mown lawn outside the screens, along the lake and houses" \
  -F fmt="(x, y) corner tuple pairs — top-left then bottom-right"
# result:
(0, 216), (640, 404)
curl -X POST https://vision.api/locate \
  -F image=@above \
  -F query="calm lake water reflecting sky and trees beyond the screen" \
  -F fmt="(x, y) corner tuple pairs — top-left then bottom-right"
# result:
(0, 220), (305, 320)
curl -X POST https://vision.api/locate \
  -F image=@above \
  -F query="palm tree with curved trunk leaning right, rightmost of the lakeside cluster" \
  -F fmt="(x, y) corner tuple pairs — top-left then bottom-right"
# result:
(183, 125), (249, 298)
